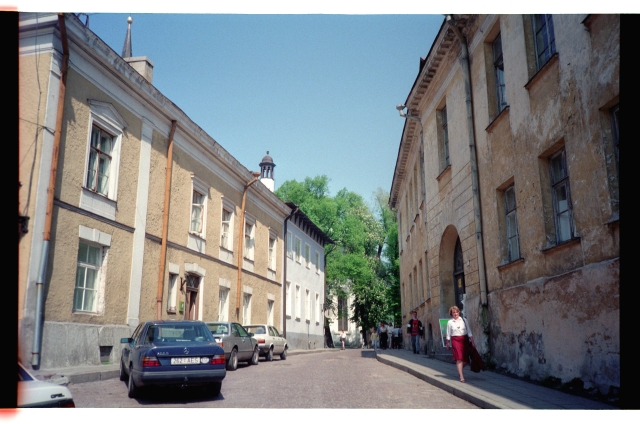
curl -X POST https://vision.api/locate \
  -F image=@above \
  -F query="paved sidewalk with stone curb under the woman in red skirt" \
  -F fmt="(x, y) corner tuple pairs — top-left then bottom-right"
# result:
(376, 349), (618, 410)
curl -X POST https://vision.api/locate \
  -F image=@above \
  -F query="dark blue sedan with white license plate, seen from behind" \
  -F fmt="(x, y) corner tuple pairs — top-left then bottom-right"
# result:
(120, 321), (227, 398)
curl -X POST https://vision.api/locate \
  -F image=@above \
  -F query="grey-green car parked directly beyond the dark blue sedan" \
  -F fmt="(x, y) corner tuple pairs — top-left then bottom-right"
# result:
(207, 321), (259, 371)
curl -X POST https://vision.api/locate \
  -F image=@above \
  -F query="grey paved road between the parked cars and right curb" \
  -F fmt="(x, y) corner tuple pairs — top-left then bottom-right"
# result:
(69, 349), (477, 409)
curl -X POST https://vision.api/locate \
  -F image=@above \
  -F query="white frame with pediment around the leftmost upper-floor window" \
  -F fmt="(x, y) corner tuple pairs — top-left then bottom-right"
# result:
(80, 99), (128, 219)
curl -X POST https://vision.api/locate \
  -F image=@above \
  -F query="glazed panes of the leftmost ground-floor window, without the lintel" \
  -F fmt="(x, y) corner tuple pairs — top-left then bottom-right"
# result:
(73, 242), (102, 312)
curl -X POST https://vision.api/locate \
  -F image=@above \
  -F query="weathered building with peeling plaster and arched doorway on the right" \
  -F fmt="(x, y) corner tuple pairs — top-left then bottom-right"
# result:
(389, 14), (620, 394)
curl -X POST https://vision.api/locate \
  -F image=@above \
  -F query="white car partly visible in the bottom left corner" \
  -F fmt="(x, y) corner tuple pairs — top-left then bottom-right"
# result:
(18, 362), (76, 408)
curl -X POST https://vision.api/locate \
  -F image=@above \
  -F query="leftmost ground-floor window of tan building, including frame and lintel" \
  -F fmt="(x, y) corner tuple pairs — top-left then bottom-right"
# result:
(73, 225), (111, 315)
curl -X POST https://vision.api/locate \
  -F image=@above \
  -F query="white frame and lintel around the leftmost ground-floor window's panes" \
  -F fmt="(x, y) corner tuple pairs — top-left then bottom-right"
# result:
(71, 225), (111, 315)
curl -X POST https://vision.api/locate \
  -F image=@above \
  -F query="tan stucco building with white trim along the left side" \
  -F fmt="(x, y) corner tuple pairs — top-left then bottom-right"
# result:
(18, 13), (291, 369)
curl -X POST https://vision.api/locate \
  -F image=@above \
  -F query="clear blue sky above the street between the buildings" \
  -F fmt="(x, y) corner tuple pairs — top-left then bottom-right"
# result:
(77, 13), (443, 205)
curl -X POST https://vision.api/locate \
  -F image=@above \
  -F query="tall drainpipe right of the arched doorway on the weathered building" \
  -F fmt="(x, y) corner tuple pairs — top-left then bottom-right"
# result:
(447, 15), (487, 307)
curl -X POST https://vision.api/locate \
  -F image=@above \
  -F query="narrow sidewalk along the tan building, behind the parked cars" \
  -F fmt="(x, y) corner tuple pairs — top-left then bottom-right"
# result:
(28, 349), (337, 386)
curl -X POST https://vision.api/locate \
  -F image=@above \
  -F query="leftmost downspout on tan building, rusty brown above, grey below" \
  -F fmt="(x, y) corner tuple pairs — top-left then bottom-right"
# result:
(31, 13), (69, 370)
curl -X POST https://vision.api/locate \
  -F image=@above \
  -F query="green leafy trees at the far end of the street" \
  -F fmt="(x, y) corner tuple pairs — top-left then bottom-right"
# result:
(276, 175), (400, 329)
